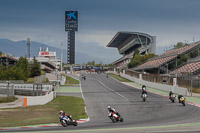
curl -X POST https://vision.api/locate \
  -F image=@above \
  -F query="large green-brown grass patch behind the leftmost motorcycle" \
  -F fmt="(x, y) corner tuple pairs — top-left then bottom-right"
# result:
(0, 96), (87, 127)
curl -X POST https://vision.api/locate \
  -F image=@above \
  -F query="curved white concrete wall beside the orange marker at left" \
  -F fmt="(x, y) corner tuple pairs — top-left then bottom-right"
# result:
(27, 91), (54, 106)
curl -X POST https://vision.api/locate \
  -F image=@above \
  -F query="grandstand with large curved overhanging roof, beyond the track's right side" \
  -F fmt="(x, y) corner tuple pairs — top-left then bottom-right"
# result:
(107, 32), (156, 69)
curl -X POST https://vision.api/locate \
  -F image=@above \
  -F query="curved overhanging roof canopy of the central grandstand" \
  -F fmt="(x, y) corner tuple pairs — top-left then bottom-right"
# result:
(107, 31), (150, 48)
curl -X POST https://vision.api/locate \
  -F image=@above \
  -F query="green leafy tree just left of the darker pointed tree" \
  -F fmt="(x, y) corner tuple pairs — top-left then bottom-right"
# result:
(17, 57), (30, 80)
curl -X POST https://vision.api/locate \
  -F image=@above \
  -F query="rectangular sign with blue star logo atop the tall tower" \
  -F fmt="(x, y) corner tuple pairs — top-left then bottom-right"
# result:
(65, 11), (78, 31)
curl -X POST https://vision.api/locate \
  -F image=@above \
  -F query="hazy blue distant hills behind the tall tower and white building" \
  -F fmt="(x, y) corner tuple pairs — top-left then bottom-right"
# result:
(0, 39), (119, 64)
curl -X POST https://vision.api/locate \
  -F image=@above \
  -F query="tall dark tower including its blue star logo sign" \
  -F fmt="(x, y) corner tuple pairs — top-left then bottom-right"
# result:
(65, 11), (78, 64)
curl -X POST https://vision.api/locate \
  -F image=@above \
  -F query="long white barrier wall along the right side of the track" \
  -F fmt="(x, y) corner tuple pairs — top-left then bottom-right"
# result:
(120, 73), (189, 96)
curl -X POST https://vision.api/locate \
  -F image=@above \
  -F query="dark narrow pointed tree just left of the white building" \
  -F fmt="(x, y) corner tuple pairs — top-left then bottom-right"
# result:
(31, 57), (41, 77)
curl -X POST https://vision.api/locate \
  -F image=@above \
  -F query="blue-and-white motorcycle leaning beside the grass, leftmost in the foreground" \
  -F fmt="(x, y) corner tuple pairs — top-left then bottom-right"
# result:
(59, 116), (78, 127)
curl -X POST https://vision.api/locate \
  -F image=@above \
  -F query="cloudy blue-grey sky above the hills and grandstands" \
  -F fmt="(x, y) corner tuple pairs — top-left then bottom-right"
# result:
(0, 0), (200, 54)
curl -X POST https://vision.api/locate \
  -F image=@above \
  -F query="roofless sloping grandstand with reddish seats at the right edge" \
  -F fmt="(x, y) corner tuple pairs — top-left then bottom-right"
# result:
(132, 42), (200, 74)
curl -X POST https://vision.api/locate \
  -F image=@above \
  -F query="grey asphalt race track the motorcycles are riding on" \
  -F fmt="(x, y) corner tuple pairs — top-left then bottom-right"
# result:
(4, 74), (200, 133)
